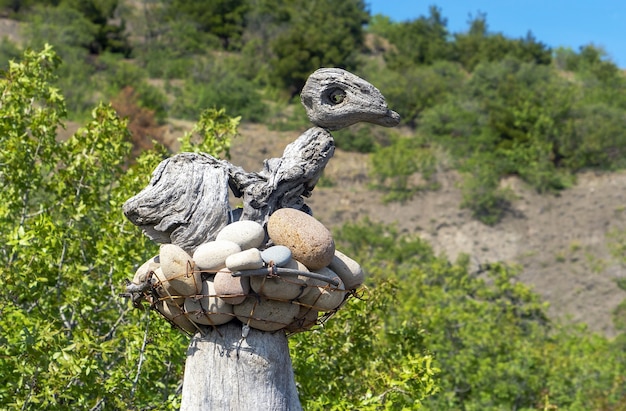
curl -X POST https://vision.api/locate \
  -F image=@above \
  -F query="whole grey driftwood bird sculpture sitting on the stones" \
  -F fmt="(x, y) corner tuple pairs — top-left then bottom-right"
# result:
(123, 68), (400, 253)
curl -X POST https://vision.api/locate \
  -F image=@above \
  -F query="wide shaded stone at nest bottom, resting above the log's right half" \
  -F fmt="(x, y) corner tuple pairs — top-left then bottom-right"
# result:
(233, 297), (300, 331)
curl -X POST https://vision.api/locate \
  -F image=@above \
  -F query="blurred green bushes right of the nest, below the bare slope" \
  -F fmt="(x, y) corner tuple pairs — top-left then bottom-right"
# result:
(331, 221), (626, 410)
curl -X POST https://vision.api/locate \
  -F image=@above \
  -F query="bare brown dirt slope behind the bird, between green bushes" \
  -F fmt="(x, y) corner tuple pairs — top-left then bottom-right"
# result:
(231, 124), (626, 336)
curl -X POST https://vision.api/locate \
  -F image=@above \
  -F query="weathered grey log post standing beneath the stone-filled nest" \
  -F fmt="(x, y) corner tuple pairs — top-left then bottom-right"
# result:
(180, 323), (302, 411)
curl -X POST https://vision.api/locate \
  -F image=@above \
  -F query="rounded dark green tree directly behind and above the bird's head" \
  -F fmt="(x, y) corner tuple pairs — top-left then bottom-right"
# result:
(246, 0), (369, 95)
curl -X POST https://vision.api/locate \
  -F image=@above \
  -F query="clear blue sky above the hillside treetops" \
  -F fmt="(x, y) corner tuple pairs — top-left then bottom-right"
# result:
(365, 0), (626, 68)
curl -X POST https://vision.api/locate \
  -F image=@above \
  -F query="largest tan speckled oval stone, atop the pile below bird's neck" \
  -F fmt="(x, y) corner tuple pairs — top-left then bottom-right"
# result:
(267, 208), (335, 270)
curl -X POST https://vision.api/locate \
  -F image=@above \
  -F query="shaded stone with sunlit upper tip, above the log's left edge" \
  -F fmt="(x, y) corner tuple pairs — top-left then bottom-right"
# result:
(185, 279), (235, 325)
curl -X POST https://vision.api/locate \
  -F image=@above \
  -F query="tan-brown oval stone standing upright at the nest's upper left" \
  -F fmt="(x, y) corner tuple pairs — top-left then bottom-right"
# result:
(159, 244), (202, 296)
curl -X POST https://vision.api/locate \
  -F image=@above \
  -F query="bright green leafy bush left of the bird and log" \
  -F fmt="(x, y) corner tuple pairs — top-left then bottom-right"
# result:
(0, 47), (228, 409)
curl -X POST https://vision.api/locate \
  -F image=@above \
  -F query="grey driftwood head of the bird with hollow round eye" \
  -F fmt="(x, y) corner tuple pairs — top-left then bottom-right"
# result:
(300, 68), (400, 130)
